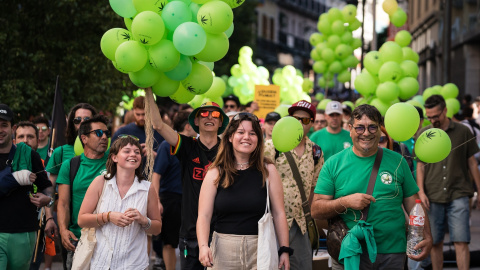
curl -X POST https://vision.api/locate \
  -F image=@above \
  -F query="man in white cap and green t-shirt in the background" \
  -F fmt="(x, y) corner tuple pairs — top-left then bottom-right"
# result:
(310, 101), (352, 161)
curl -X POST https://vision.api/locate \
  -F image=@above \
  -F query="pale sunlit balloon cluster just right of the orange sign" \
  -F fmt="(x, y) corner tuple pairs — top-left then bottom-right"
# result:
(272, 65), (313, 105)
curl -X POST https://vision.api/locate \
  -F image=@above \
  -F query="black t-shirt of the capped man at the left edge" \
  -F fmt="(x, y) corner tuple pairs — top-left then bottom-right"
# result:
(0, 150), (52, 233)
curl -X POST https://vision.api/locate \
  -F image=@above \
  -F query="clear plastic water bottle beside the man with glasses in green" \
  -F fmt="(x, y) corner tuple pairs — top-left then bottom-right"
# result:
(407, 200), (425, 255)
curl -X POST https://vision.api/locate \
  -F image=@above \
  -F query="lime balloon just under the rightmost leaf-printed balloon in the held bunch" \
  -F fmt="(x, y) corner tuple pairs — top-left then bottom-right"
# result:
(195, 32), (230, 62)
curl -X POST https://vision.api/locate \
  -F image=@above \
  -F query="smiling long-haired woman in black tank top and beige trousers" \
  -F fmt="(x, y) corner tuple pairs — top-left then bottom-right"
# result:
(197, 113), (290, 270)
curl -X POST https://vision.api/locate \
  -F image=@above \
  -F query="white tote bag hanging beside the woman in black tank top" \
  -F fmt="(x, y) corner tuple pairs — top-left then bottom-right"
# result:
(257, 179), (278, 270)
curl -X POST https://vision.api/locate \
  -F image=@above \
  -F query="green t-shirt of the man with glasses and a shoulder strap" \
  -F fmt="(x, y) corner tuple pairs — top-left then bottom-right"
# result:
(315, 147), (419, 254)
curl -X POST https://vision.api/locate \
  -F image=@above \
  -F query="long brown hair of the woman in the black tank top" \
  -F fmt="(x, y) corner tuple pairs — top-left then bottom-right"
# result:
(210, 113), (272, 188)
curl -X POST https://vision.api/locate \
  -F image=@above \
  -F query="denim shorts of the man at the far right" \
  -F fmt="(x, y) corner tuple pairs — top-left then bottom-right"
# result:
(428, 197), (470, 245)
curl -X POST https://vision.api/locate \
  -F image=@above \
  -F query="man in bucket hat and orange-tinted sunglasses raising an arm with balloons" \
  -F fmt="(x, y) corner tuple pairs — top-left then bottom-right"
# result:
(147, 97), (229, 270)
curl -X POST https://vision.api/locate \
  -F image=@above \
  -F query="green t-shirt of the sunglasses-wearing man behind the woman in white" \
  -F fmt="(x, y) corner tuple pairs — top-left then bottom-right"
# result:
(57, 153), (108, 238)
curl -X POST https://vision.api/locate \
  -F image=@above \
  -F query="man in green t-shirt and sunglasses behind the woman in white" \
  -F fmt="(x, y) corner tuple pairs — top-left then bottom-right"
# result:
(57, 115), (110, 269)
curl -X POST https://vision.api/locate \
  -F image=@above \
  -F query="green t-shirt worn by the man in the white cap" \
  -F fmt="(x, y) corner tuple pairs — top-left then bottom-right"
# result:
(310, 128), (352, 161)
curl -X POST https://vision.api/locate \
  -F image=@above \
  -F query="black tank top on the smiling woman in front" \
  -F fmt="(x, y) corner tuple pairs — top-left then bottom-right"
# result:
(214, 168), (267, 235)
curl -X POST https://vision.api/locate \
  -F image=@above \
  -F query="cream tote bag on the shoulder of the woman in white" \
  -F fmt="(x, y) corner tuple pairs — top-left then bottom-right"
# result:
(72, 180), (107, 270)
